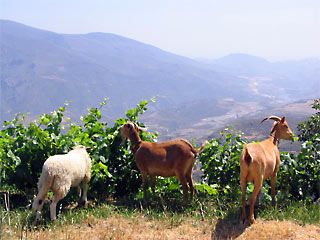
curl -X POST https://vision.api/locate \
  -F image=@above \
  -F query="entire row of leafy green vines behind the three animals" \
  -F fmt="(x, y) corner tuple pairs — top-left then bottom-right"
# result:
(0, 97), (320, 210)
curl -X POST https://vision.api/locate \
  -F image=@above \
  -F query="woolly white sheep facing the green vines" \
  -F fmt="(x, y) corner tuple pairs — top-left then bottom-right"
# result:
(32, 145), (91, 220)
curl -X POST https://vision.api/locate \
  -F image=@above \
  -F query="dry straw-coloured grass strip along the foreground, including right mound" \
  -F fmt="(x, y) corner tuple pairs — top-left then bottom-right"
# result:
(0, 201), (320, 240)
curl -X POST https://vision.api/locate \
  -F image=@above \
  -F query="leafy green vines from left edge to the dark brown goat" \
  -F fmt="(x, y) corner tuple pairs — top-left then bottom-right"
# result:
(0, 100), (156, 201)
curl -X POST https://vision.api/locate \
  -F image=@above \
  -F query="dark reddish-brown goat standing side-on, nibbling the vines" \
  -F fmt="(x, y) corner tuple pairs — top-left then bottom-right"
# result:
(120, 122), (204, 204)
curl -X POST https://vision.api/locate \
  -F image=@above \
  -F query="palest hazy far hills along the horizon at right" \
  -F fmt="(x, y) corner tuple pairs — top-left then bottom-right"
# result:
(205, 53), (320, 102)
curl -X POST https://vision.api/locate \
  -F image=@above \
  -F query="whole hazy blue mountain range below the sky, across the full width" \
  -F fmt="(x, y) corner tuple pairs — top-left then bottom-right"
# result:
(0, 20), (320, 141)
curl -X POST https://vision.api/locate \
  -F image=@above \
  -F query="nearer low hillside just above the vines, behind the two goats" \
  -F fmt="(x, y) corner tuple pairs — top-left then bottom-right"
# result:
(142, 99), (315, 144)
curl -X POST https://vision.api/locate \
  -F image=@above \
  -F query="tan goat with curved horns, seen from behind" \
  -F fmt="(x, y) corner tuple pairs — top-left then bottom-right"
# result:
(240, 116), (293, 223)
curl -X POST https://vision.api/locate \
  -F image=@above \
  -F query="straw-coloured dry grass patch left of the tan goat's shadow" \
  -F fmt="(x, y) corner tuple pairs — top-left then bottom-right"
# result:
(4, 216), (212, 240)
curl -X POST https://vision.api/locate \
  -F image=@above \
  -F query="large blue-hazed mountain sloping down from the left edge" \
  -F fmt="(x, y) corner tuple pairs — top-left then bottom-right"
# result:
(0, 20), (251, 123)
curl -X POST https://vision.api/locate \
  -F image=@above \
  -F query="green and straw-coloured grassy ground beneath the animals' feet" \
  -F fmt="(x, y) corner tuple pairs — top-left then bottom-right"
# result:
(0, 199), (320, 240)
